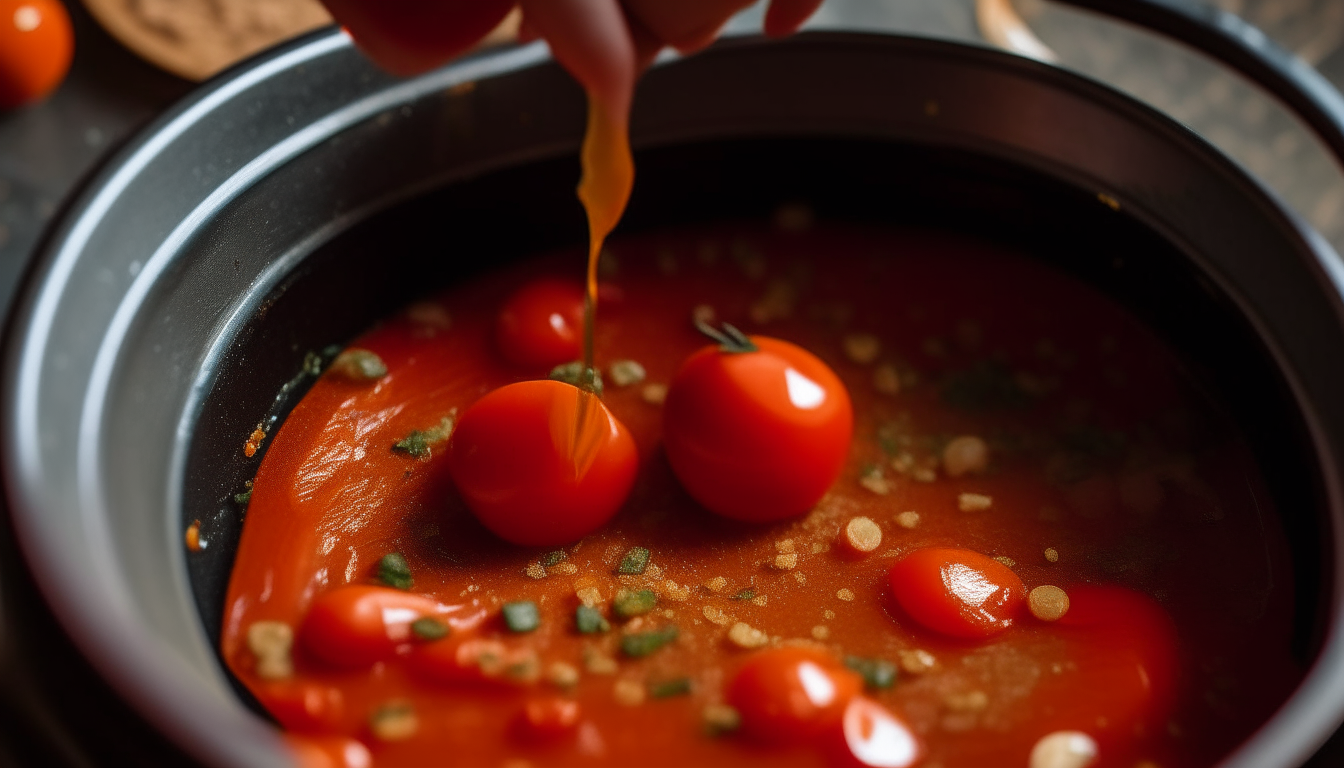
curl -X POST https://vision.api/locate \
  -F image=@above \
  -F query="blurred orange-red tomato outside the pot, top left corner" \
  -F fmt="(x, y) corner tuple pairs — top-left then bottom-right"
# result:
(0, 0), (75, 109)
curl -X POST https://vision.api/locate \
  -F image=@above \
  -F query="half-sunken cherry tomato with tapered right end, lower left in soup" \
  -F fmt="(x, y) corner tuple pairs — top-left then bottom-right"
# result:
(298, 584), (448, 668)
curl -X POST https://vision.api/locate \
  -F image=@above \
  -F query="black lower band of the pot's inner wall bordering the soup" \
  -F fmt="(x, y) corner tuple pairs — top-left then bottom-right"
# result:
(181, 139), (1328, 698)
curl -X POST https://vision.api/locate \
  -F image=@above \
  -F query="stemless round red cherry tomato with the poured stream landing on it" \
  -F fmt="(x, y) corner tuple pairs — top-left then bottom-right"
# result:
(448, 381), (638, 546)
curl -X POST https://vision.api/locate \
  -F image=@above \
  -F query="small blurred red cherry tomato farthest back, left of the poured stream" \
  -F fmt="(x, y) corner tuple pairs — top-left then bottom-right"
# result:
(495, 280), (583, 371)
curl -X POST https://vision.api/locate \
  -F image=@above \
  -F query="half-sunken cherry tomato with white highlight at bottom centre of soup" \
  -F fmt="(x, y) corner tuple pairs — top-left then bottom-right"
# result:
(727, 647), (863, 744)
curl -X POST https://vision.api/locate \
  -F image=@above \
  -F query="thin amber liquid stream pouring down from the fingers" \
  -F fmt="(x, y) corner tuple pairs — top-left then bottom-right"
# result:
(570, 93), (634, 477)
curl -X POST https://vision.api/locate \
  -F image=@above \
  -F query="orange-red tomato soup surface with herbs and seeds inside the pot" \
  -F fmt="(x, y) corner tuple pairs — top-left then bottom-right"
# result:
(222, 216), (1301, 768)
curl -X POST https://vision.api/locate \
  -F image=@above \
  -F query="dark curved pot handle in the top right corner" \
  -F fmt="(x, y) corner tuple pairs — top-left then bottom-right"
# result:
(1056, 0), (1344, 164)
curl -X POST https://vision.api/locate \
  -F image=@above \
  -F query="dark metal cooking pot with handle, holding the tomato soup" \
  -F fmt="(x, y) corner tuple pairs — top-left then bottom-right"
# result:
(3, 0), (1344, 768)
